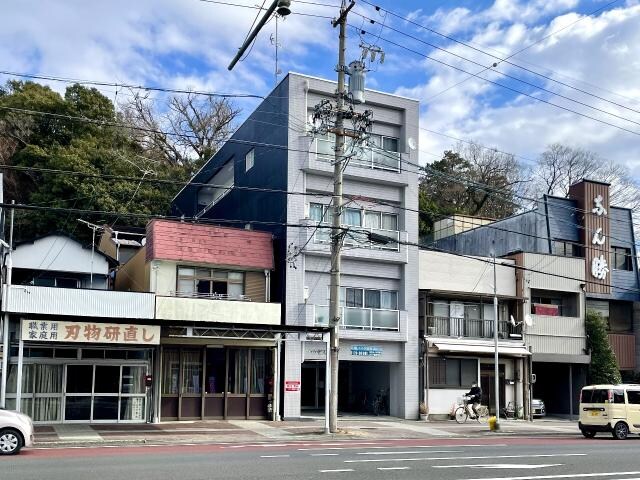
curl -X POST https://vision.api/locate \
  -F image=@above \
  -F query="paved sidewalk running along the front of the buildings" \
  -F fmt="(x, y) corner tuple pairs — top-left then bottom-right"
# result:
(35, 417), (579, 447)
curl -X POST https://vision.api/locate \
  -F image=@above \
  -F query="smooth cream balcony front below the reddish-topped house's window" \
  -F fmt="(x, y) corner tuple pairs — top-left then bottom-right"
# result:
(156, 296), (280, 325)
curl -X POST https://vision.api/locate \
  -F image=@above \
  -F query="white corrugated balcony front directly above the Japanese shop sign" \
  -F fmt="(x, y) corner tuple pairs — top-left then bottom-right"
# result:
(3, 285), (155, 319)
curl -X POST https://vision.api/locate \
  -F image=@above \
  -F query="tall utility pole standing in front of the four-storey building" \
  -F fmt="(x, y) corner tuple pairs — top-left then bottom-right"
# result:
(329, 1), (355, 433)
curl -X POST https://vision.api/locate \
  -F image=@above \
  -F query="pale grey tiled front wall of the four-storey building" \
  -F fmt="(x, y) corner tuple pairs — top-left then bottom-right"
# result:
(284, 74), (419, 418)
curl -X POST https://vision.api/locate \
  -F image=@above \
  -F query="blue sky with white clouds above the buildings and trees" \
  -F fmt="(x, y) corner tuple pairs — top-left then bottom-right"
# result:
(0, 0), (640, 177)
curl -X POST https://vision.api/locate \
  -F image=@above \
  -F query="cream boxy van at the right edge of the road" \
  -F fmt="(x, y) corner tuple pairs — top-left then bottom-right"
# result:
(578, 385), (640, 440)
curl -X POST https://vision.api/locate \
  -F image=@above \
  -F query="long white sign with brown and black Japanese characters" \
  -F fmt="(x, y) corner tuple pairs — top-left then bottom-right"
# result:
(22, 320), (160, 345)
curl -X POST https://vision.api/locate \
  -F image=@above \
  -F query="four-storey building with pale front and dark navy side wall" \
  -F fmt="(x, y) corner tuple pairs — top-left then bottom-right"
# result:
(173, 73), (419, 418)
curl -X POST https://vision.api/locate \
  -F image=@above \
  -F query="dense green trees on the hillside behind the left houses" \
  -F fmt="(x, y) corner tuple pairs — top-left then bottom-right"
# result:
(0, 81), (189, 244)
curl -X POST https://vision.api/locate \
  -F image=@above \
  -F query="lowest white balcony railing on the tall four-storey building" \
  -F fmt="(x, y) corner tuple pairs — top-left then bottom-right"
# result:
(315, 305), (400, 332)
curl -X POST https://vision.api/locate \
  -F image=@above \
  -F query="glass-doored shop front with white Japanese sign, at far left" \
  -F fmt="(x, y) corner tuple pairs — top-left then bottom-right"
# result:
(6, 319), (160, 423)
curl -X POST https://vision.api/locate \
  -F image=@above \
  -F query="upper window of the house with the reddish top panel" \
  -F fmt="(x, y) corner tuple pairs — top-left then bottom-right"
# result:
(177, 267), (244, 298)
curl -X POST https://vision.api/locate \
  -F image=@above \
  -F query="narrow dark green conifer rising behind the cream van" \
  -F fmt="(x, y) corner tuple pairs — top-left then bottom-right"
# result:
(585, 310), (622, 384)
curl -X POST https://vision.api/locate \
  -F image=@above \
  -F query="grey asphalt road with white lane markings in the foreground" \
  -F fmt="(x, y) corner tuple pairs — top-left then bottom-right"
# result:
(0, 436), (640, 480)
